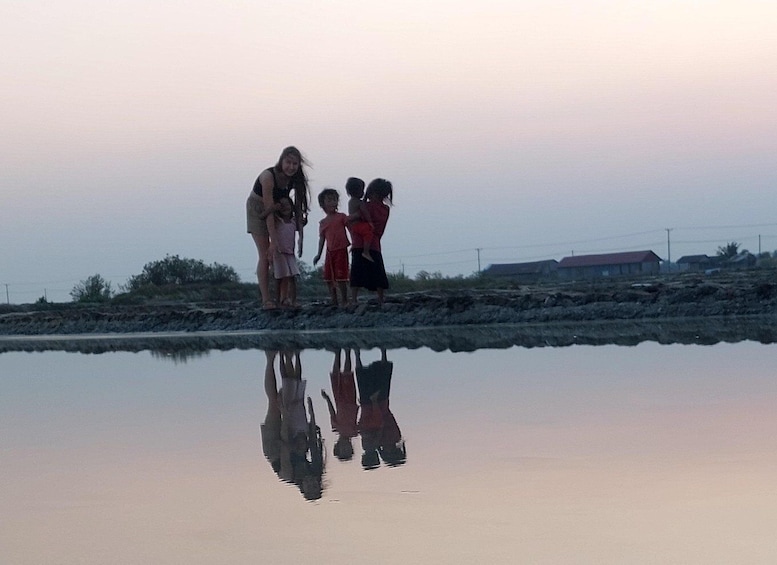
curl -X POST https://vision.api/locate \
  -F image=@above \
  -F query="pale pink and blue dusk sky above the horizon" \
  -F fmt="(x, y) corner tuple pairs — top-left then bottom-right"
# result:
(0, 0), (777, 303)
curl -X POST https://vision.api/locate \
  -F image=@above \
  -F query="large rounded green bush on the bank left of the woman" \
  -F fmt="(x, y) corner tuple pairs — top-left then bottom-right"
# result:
(125, 255), (240, 291)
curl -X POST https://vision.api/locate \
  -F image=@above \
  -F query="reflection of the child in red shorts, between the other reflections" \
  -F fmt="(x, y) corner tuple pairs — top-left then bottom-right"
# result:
(321, 349), (359, 461)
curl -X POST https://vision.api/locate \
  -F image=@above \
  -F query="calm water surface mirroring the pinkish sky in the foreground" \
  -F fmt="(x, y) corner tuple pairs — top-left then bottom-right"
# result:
(0, 342), (777, 564)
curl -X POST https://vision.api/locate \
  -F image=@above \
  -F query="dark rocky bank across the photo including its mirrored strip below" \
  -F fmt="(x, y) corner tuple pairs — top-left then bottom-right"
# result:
(0, 271), (777, 351)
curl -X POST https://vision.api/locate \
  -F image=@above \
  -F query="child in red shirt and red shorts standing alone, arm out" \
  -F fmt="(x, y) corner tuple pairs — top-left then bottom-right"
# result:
(313, 188), (351, 306)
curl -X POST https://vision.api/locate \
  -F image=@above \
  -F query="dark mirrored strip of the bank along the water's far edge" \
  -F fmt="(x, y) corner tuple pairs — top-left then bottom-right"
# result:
(0, 317), (777, 352)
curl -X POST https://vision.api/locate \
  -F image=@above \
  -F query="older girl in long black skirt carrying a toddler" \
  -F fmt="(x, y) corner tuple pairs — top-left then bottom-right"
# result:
(350, 179), (394, 307)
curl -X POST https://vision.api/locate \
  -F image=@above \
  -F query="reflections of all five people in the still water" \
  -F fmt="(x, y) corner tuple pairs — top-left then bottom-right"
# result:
(261, 348), (407, 500)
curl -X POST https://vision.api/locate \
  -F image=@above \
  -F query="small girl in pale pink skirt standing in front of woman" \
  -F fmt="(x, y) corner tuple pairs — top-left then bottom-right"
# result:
(273, 196), (302, 308)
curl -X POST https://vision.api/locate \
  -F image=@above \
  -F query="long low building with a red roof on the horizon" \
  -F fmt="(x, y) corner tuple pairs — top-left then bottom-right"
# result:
(558, 251), (661, 280)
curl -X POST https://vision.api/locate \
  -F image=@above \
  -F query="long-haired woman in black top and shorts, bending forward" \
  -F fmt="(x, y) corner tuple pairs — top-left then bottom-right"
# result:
(246, 147), (310, 309)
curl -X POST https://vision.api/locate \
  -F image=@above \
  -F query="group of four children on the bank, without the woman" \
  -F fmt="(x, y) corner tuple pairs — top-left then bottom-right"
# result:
(266, 177), (393, 307)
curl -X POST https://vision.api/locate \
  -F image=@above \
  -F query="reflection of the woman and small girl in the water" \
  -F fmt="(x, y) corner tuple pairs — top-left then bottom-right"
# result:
(261, 350), (324, 500)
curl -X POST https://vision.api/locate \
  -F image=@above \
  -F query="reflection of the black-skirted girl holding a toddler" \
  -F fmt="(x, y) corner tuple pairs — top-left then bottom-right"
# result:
(356, 348), (407, 469)
